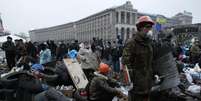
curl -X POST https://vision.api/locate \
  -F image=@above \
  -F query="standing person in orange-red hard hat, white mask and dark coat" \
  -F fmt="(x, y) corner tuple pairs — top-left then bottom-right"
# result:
(122, 16), (154, 101)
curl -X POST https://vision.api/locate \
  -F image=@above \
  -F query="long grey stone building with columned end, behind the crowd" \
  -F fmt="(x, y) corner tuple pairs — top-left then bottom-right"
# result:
(29, 1), (137, 42)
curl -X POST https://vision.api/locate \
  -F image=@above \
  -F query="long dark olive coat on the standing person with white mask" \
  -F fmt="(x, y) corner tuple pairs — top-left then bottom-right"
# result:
(122, 33), (153, 94)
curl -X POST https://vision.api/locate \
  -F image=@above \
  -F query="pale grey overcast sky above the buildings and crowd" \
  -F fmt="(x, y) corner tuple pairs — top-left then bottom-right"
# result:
(0, 0), (201, 33)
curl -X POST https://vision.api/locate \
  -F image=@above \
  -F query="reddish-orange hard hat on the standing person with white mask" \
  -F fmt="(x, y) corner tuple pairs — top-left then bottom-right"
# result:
(136, 16), (154, 25)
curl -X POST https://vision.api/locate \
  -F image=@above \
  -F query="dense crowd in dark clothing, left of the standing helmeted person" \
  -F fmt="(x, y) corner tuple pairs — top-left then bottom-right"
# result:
(1, 37), (123, 72)
